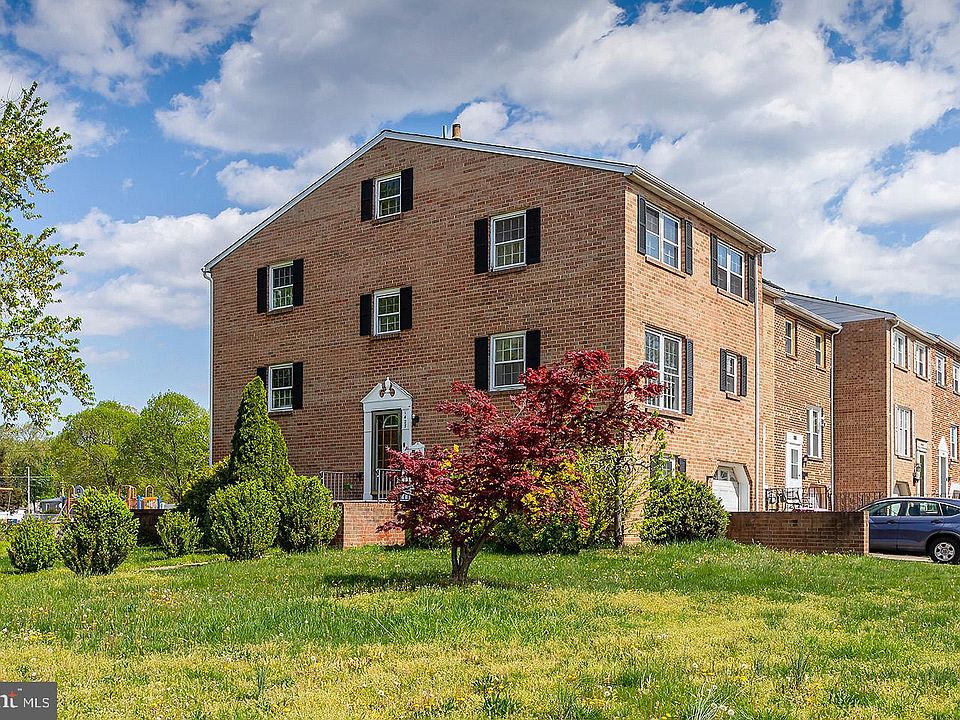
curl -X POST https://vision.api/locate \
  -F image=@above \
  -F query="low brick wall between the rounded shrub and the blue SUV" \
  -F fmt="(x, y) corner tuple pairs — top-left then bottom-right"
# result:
(727, 512), (870, 555)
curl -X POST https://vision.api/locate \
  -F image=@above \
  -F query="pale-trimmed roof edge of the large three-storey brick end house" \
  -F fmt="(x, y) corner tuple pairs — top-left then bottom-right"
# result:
(203, 130), (774, 272)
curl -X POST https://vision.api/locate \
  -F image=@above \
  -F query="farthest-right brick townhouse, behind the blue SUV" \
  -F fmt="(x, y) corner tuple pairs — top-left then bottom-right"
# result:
(785, 293), (960, 509)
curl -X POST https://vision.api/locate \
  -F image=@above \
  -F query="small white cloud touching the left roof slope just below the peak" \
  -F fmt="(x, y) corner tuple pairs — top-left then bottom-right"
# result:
(217, 139), (356, 207)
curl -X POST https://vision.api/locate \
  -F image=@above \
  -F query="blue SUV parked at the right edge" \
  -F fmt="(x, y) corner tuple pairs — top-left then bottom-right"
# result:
(863, 497), (960, 563)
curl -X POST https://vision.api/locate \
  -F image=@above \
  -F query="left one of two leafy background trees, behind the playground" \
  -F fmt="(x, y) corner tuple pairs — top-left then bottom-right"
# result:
(52, 400), (139, 488)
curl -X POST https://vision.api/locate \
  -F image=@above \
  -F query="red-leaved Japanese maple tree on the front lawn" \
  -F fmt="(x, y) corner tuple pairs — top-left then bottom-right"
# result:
(384, 350), (667, 583)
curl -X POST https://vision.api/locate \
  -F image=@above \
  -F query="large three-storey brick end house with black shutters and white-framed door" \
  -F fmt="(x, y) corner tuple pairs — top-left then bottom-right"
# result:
(204, 131), (776, 510)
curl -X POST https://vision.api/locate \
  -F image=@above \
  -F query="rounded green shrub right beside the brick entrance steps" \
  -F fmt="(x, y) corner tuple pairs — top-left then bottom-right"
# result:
(277, 475), (341, 552)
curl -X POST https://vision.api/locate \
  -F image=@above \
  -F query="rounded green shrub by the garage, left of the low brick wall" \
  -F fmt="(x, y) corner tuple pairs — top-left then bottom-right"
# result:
(639, 473), (730, 543)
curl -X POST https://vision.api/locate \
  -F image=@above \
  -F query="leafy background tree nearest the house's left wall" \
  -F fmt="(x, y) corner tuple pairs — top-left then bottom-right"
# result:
(120, 392), (210, 503)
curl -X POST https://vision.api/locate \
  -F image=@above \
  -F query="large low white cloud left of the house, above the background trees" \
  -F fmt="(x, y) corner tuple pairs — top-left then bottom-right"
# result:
(58, 208), (269, 335)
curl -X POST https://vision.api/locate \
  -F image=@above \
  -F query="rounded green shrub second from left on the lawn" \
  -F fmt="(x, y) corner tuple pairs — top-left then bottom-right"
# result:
(60, 490), (138, 575)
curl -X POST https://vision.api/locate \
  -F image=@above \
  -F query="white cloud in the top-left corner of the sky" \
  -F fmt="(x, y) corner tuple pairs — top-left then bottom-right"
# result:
(9, 0), (255, 101)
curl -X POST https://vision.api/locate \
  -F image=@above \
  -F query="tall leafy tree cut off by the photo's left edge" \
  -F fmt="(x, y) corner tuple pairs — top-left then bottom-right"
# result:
(0, 83), (93, 427)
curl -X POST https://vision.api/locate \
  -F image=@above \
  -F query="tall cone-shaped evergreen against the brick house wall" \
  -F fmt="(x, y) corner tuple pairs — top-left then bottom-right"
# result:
(227, 377), (293, 490)
